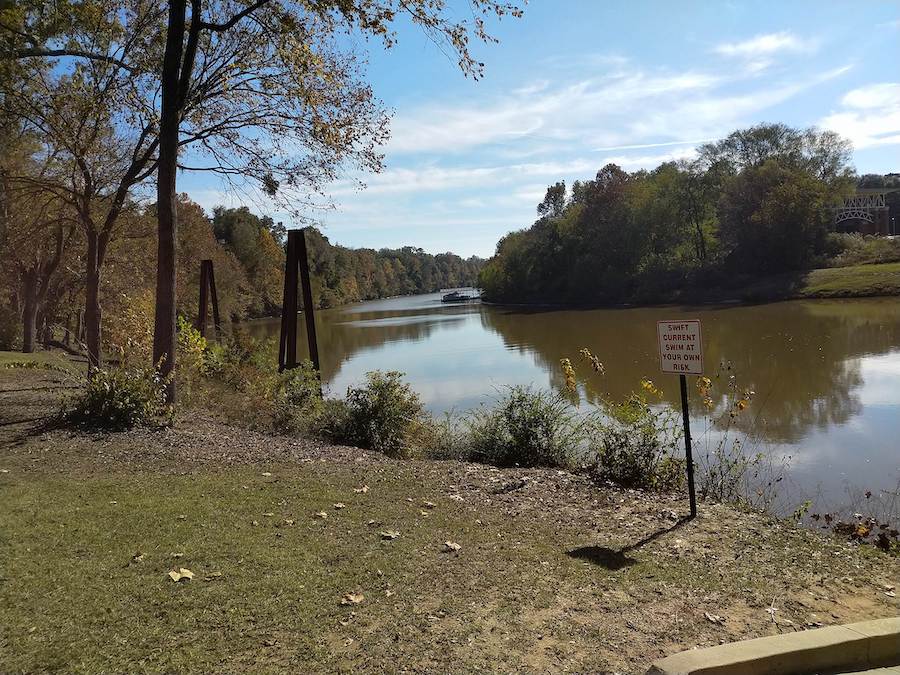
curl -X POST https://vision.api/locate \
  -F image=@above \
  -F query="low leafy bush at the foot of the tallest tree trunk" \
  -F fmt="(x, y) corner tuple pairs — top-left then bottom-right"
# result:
(66, 366), (172, 431)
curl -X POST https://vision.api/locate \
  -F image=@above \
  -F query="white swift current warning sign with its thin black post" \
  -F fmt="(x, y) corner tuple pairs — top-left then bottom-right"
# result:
(656, 319), (703, 518)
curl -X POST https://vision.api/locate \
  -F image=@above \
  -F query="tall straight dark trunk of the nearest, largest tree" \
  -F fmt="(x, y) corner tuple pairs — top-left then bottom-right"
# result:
(153, 0), (186, 404)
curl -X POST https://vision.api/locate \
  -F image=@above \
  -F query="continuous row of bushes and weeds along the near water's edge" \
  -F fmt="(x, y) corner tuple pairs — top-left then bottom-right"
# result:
(29, 321), (900, 552)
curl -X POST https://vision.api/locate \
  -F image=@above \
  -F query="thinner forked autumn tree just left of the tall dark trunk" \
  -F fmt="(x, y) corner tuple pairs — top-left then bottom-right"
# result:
(0, 0), (162, 366)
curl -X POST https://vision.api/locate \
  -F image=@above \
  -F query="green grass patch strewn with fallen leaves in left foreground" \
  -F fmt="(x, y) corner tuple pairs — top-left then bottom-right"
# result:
(0, 471), (600, 672)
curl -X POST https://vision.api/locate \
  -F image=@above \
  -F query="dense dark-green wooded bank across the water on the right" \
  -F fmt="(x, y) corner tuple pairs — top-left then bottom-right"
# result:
(480, 124), (900, 304)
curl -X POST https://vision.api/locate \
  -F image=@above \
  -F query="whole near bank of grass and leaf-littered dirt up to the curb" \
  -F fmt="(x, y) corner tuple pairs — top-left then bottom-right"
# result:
(0, 362), (900, 673)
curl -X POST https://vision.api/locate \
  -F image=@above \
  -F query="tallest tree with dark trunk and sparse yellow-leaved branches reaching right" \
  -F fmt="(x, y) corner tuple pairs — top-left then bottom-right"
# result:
(154, 0), (521, 399)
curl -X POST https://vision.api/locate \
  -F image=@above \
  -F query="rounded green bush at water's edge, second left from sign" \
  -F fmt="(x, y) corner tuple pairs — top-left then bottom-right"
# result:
(468, 386), (584, 467)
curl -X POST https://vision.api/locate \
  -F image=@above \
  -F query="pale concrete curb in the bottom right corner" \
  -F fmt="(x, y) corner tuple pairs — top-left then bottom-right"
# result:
(647, 617), (900, 675)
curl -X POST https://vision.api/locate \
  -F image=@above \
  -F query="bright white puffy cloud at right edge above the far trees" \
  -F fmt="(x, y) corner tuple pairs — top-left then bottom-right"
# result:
(819, 82), (900, 150)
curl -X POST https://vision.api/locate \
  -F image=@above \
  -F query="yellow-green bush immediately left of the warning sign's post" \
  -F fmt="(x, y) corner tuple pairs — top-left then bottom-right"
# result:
(590, 384), (684, 490)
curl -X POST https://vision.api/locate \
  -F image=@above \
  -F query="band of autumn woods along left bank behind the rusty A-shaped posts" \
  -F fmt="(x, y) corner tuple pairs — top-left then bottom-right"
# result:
(0, 191), (483, 354)
